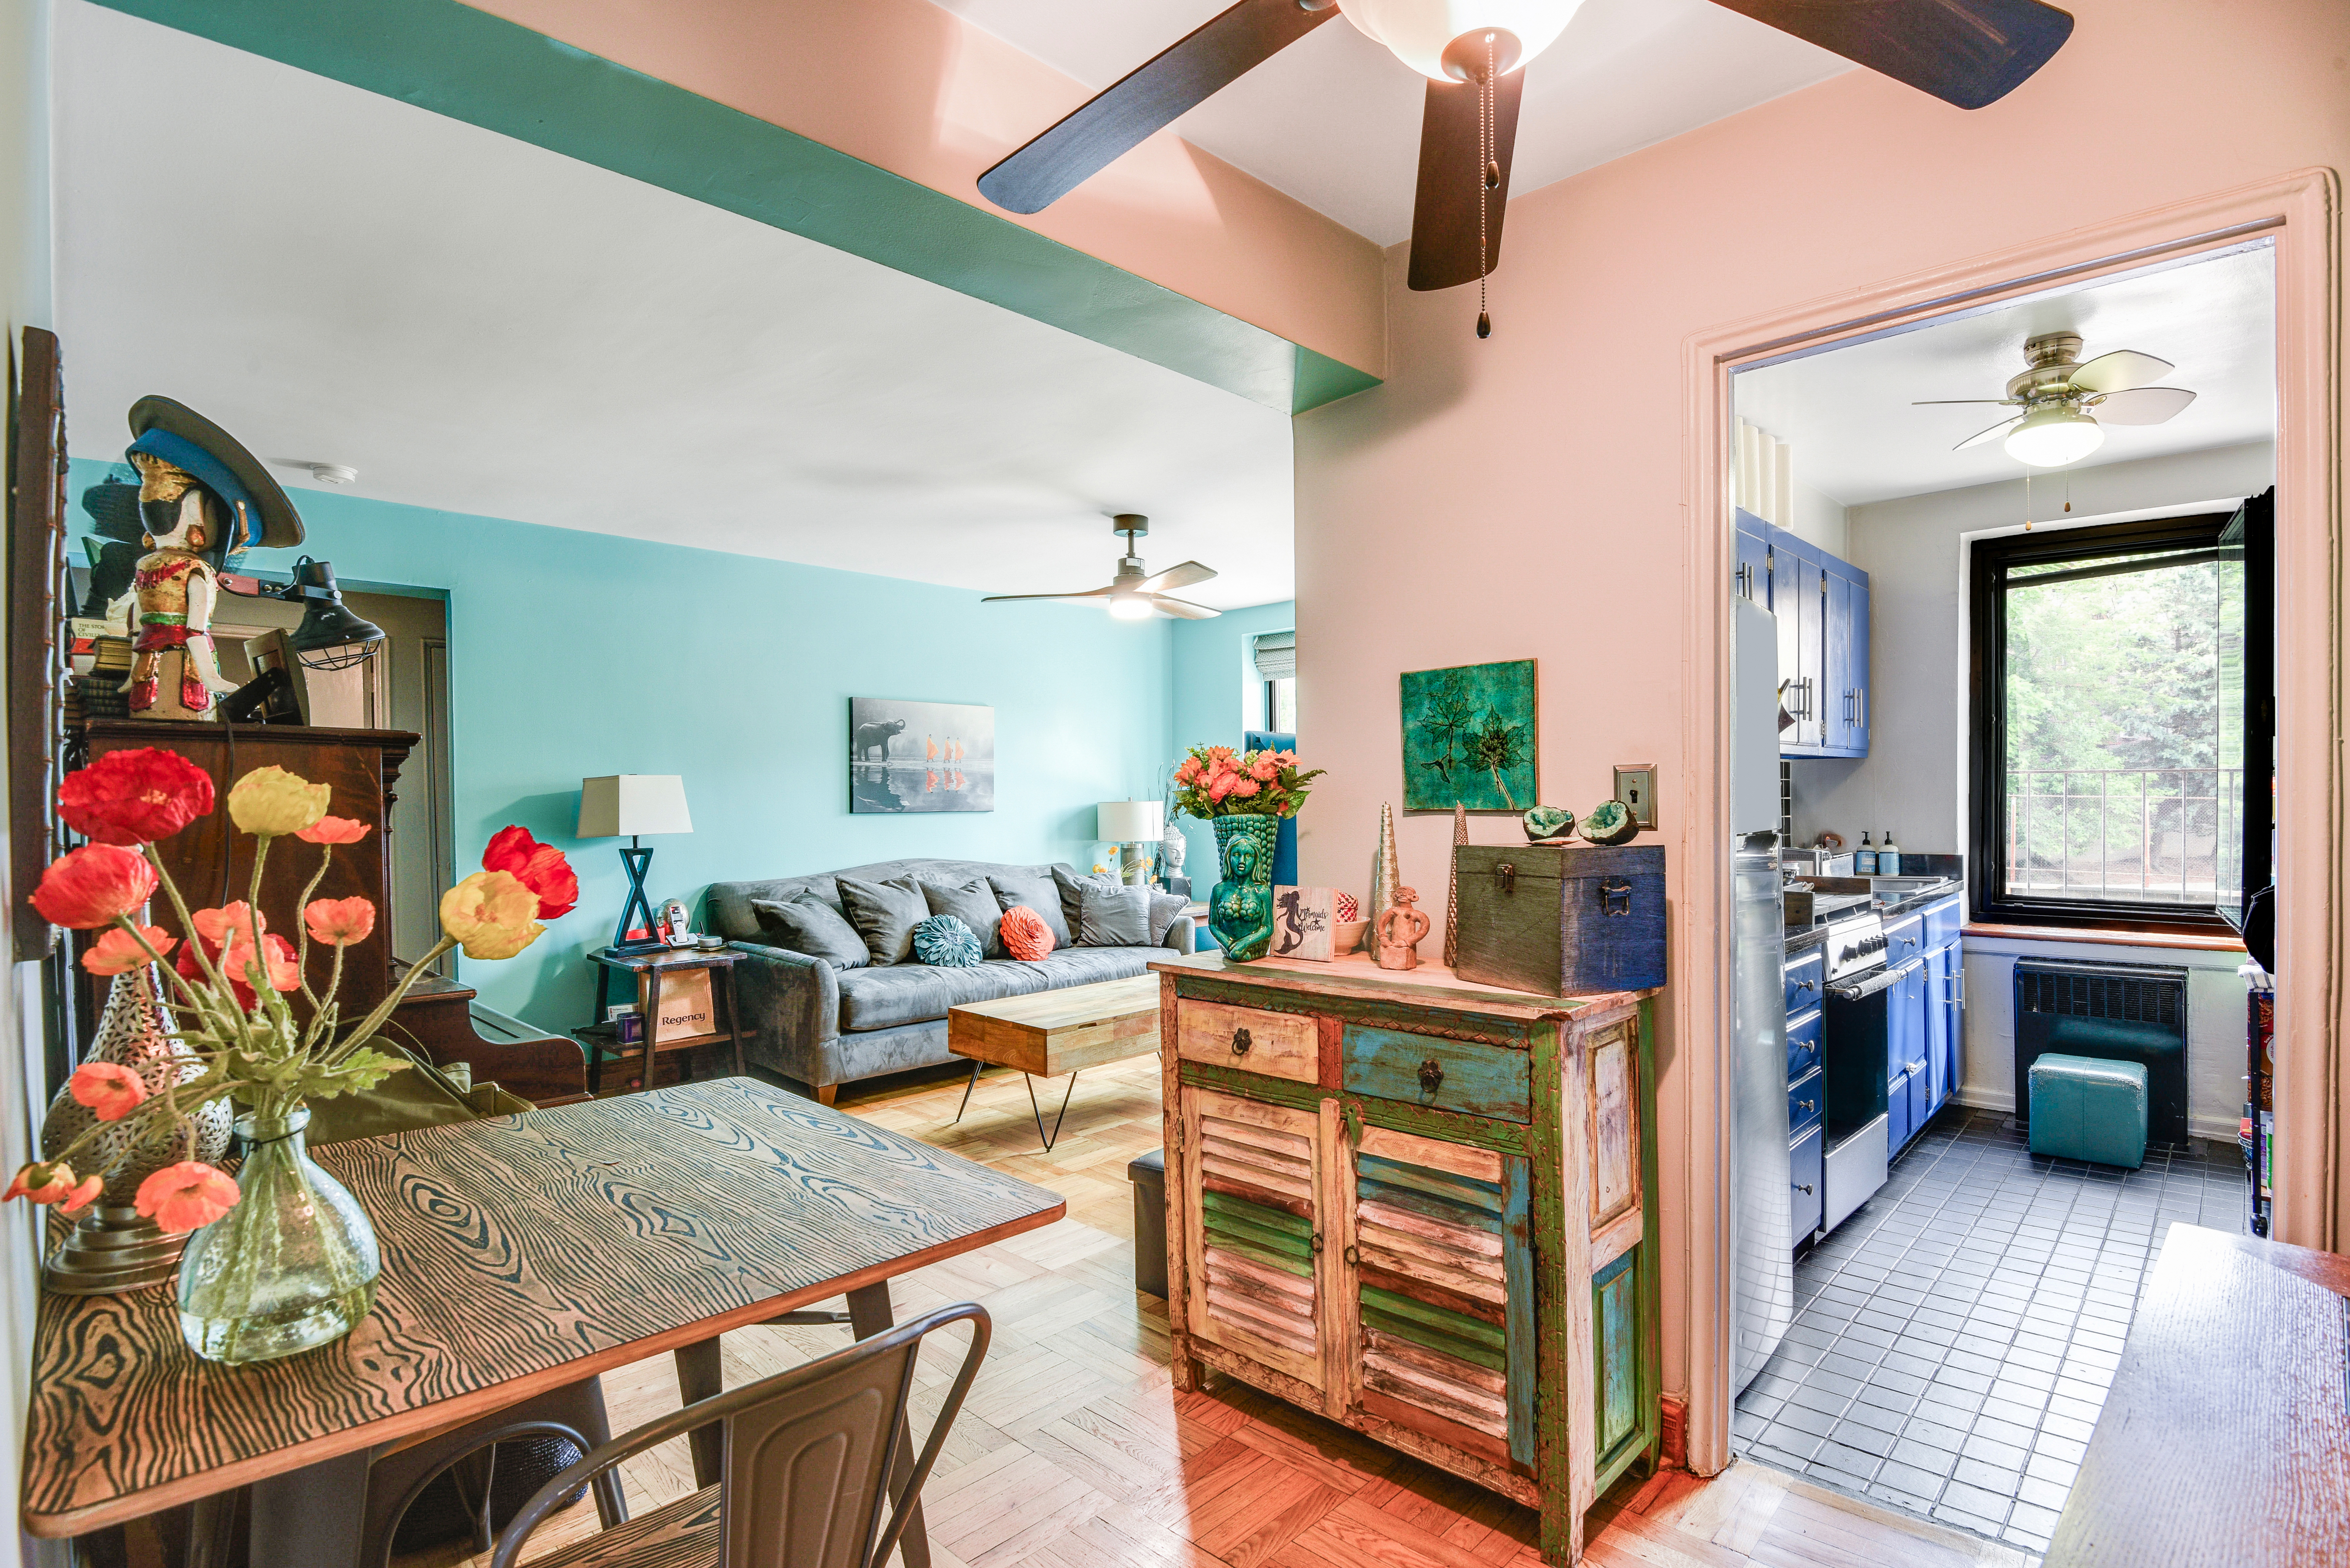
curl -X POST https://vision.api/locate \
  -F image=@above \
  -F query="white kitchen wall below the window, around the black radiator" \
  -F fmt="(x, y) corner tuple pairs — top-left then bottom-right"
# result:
(1957, 936), (2244, 1140)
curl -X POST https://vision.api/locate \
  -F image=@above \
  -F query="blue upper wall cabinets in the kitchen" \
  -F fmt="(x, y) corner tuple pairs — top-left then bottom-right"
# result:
(1732, 510), (1868, 757)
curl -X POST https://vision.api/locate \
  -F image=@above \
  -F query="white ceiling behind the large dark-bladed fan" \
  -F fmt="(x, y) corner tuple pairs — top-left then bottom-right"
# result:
(938, 0), (1852, 245)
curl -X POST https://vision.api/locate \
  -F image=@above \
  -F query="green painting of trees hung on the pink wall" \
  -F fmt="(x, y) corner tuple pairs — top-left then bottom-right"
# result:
(1403, 658), (1534, 813)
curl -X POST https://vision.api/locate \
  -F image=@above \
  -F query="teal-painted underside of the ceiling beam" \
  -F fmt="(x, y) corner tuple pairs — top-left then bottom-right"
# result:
(98, 0), (1379, 414)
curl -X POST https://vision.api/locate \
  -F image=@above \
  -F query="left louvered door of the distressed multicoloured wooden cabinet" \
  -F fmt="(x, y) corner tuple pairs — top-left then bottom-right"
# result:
(1182, 1084), (1325, 1389)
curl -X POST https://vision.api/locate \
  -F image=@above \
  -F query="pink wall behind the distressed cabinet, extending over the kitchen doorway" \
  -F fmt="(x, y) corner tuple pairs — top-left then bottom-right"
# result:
(1297, 0), (2350, 1389)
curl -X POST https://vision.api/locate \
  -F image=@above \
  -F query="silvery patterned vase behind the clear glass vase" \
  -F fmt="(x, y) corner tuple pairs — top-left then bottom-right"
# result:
(40, 964), (230, 1295)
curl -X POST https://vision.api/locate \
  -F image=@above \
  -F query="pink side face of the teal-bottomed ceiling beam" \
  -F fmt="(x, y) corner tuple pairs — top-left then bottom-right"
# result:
(472, 0), (1386, 376)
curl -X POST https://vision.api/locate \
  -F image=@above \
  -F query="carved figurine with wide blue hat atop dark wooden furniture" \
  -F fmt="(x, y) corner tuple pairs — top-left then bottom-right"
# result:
(122, 397), (303, 720)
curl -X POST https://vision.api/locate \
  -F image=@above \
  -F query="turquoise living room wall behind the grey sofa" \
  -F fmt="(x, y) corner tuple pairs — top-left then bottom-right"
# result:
(73, 461), (1175, 1029)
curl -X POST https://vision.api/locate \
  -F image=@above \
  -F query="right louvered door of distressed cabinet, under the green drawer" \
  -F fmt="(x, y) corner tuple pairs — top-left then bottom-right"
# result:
(1347, 1124), (1534, 1469)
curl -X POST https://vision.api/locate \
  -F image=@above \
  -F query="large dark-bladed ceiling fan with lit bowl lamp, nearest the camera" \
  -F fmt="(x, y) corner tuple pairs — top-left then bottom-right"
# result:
(980, 0), (2073, 336)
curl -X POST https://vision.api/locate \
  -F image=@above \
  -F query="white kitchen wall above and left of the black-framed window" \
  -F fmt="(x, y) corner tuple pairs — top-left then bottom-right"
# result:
(1795, 442), (2277, 853)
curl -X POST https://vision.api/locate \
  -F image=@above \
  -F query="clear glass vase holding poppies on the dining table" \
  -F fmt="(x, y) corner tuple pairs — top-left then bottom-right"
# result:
(179, 1105), (383, 1363)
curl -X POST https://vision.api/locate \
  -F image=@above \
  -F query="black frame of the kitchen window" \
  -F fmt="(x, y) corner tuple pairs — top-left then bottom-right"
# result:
(1967, 508), (2235, 938)
